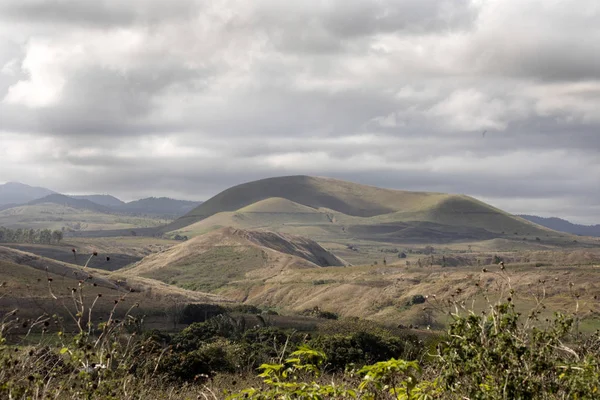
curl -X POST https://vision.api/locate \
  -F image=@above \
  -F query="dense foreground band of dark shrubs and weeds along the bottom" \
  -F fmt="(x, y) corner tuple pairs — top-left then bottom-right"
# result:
(0, 265), (600, 399)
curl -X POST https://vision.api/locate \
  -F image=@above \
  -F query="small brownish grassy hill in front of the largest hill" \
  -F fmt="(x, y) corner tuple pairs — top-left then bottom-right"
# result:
(122, 228), (346, 291)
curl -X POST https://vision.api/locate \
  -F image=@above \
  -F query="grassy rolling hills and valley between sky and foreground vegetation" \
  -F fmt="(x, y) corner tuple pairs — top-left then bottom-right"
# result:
(0, 176), (600, 329)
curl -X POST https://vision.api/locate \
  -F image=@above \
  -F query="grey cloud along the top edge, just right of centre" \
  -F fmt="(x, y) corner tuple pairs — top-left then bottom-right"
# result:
(253, 0), (476, 53)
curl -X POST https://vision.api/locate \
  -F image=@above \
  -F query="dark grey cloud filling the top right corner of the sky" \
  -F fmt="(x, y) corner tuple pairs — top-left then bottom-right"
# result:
(463, 0), (600, 81)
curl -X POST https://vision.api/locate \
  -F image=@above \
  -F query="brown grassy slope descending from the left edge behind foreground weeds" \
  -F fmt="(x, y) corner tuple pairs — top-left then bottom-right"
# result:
(0, 246), (226, 316)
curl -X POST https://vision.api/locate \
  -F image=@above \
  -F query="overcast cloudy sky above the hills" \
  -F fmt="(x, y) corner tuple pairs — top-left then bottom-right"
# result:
(0, 0), (600, 224)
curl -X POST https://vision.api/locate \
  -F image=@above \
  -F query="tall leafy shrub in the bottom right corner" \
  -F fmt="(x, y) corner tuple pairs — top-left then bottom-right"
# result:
(438, 301), (600, 399)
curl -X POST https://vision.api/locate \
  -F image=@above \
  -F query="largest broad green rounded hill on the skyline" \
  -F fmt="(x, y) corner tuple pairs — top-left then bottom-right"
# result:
(162, 176), (556, 242)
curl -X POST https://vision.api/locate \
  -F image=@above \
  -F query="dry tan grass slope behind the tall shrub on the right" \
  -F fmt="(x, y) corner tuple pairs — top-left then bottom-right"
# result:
(212, 254), (600, 326)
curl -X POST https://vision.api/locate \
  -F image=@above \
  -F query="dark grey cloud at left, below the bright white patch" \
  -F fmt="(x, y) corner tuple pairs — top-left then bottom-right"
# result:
(0, 65), (203, 136)
